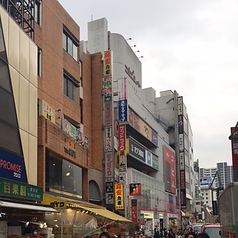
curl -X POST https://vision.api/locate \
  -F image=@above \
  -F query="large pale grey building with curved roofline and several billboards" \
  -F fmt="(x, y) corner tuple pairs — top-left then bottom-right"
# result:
(87, 18), (179, 233)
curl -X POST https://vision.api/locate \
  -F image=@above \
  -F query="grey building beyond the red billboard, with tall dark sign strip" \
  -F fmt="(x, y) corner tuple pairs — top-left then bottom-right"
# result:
(142, 88), (198, 212)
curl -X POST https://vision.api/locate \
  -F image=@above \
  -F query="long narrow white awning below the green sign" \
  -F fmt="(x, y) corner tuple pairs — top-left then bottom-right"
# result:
(0, 201), (57, 212)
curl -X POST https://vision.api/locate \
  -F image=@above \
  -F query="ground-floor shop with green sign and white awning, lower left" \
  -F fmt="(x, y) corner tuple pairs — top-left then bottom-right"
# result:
(0, 178), (57, 238)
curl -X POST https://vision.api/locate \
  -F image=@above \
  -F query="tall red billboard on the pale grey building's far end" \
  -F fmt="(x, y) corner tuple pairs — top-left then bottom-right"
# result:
(164, 146), (176, 194)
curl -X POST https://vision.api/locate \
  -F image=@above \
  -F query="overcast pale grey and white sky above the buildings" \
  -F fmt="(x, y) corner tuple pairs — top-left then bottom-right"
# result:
(59, 0), (238, 168)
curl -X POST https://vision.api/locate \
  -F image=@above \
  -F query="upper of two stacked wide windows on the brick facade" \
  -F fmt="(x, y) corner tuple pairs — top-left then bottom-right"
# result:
(63, 28), (79, 60)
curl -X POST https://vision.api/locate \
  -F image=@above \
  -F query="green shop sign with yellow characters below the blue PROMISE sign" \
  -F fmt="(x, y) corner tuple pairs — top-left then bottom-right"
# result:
(0, 178), (43, 201)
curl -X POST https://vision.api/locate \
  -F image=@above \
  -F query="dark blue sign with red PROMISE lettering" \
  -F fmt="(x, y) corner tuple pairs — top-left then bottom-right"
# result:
(0, 149), (27, 183)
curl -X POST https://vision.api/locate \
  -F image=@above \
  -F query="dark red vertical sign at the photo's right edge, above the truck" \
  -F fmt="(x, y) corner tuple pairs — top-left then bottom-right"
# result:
(231, 127), (238, 182)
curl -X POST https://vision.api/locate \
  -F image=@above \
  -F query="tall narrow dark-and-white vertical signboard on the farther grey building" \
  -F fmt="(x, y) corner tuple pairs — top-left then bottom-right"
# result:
(177, 97), (187, 209)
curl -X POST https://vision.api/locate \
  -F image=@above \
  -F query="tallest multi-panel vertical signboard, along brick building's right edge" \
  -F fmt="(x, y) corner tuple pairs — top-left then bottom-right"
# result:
(103, 50), (114, 208)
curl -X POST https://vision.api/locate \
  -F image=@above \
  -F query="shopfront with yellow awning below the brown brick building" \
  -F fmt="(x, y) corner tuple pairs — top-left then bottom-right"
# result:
(42, 194), (133, 238)
